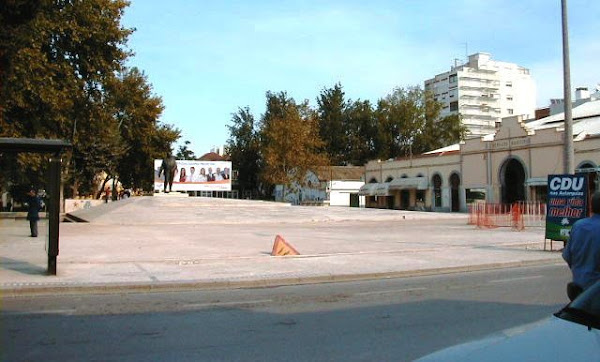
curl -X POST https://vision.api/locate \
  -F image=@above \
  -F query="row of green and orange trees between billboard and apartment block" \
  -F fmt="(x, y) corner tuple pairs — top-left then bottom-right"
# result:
(228, 84), (465, 198)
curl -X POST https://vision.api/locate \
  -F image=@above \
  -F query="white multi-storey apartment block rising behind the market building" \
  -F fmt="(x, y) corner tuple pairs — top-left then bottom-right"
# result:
(425, 53), (536, 137)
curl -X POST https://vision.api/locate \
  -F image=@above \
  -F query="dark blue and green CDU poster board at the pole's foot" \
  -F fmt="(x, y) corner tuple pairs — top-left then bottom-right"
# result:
(546, 174), (588, 241)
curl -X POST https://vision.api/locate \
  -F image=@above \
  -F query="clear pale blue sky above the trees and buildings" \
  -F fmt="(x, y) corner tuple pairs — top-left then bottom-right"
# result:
(123, 0), (600, 155)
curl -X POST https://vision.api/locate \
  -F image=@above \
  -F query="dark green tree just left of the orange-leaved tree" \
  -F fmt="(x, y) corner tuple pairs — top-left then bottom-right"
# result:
(227, 107), (261, 195)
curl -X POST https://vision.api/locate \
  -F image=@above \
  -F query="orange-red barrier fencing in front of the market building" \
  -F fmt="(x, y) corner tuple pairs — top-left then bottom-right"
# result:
(468, 201), (546, 230)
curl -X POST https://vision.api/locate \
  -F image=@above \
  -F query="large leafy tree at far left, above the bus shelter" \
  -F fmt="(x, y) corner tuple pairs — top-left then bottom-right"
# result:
(0, 0), (131, 195)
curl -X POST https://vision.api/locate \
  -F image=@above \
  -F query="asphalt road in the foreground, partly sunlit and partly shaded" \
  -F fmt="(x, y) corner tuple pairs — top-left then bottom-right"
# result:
(0, 264), (569, 361)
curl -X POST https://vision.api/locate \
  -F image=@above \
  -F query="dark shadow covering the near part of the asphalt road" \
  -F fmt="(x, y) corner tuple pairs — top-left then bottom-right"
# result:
(2, 299), (560, 361)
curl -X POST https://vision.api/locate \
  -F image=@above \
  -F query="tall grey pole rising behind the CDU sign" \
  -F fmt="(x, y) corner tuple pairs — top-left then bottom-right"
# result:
(561, 0), (575, 174)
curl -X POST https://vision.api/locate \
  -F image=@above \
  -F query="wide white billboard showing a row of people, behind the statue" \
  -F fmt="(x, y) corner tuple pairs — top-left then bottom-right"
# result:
(154, 160), (231, 191)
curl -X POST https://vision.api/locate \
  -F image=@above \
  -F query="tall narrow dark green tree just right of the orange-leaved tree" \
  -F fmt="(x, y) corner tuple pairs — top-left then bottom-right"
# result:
(317, 83), (349, 165)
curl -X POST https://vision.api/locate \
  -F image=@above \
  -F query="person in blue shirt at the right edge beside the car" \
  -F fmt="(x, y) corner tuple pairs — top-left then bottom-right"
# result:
(562, 191), (600, 300)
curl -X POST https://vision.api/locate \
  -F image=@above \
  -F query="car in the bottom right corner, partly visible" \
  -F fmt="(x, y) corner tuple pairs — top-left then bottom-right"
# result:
(417, 281), (600, 362)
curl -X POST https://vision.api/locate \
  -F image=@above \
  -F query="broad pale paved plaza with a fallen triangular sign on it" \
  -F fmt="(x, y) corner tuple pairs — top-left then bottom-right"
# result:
(0, 196), (566, 296)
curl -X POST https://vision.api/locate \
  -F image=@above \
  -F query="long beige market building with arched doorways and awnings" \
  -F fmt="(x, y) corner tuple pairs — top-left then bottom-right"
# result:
(359, 97), (600, 212)
